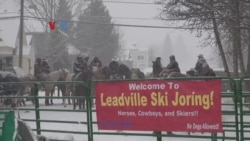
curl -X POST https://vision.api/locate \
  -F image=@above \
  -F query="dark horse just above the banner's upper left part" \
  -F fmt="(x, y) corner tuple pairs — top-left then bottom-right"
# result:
(109, 61), (132, 79)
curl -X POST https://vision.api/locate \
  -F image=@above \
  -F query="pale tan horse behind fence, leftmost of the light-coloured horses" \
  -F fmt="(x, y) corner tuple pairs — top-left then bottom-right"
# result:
(44, 69), (67, 106)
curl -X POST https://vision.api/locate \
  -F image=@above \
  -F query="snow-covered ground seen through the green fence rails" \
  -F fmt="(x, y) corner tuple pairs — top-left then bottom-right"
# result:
(16, 92), (249, 141)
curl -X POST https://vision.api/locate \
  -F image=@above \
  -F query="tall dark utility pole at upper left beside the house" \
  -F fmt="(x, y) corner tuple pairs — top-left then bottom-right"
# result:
(19, 0), (24, 68)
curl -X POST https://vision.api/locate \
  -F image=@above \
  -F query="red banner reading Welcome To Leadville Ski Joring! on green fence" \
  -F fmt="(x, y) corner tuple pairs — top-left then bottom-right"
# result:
(96, 80), (222, 132)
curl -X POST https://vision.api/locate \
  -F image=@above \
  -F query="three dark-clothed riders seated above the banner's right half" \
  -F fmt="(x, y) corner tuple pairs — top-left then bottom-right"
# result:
(152, 54), (211, 77)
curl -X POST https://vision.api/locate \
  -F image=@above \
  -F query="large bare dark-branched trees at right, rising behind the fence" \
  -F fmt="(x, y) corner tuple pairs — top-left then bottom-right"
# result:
(161, 0), (249, 77)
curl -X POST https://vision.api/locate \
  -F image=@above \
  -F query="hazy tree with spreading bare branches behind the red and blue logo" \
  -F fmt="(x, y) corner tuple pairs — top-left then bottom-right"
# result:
(25, 0), (87, 69)
